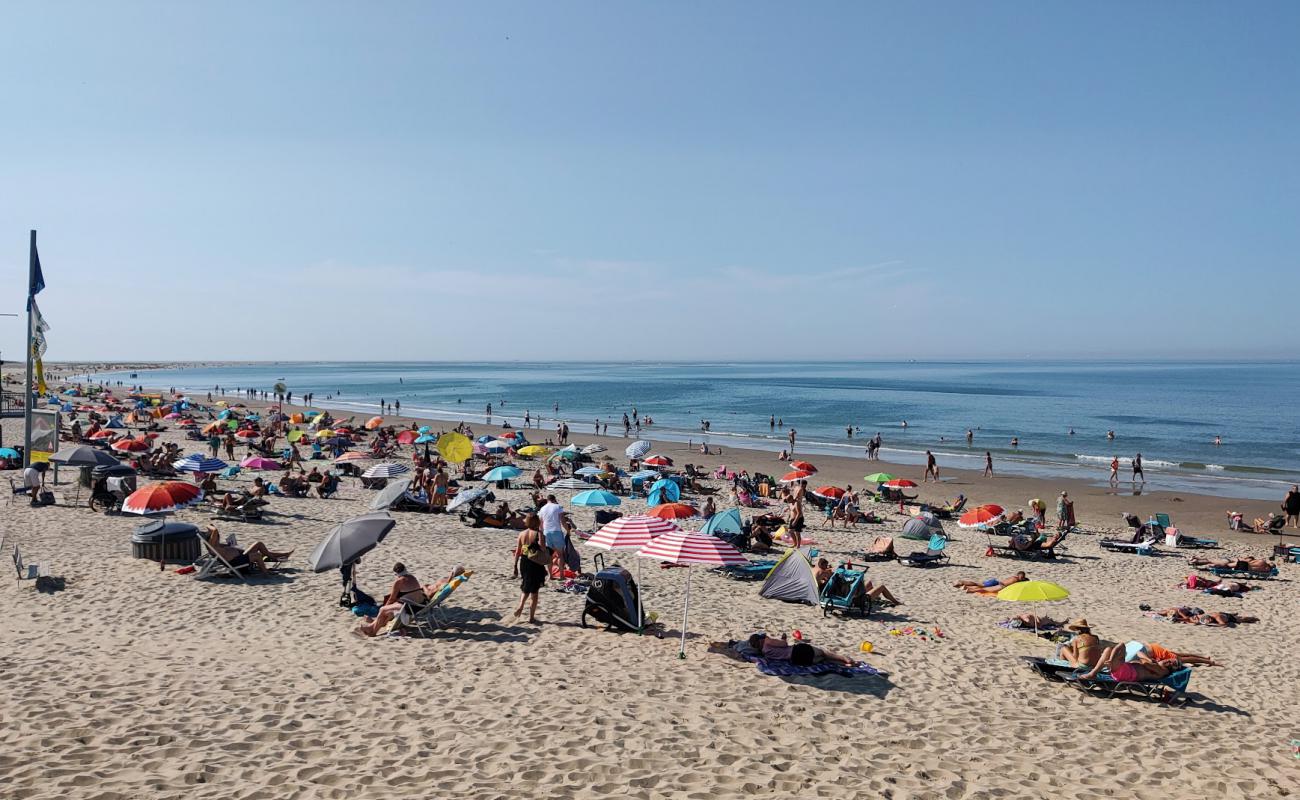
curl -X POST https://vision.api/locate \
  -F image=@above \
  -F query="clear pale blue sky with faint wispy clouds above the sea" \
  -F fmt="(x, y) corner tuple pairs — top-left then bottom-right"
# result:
(0, 0), (1300, 360)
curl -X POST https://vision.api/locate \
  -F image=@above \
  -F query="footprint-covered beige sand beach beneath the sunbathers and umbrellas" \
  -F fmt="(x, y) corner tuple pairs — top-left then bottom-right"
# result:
(0, 387), (1300, 799)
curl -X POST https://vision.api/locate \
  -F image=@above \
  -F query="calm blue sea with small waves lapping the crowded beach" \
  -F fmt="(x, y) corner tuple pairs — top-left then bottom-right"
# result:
(99, 362), (1300, 498)
